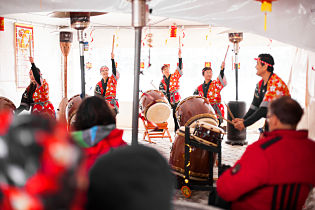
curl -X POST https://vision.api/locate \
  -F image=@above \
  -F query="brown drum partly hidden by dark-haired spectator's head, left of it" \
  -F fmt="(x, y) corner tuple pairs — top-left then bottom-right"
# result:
(66, 94), (82, 130)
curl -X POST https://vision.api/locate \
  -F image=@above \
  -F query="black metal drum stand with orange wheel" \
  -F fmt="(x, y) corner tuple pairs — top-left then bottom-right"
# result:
(181, 126), (223, 198)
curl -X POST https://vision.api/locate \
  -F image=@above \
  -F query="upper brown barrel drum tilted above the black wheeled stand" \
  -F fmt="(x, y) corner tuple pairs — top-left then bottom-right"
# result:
(175, 96), (218, 126)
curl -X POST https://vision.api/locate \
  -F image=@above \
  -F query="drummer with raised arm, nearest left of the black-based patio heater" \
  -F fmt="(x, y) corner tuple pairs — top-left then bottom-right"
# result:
(194, 62), (227, 124)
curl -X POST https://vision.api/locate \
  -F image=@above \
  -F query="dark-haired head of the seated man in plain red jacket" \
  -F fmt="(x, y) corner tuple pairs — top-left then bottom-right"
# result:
(267, 96), (303, 131)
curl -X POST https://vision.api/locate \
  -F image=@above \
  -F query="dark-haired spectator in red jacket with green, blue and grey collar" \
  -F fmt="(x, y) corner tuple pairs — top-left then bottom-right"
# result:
(72, 96), (127, 169)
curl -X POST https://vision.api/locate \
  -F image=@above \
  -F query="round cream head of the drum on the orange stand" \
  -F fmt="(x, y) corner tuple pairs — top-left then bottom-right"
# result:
(146, 103), (171, 123)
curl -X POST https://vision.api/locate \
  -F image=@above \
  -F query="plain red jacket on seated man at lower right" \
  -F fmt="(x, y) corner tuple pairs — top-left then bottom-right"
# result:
(217, 130), (315, 209)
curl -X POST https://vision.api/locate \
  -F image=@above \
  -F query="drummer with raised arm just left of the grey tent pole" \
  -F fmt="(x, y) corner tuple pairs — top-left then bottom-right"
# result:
(94, 53), (119, 114)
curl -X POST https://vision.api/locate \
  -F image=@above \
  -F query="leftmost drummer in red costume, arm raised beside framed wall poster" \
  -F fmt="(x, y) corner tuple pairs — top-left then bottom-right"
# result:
(15, 57), (56, 119)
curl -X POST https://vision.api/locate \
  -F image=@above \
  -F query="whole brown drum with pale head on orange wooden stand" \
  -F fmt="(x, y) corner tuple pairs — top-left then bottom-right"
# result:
(140, 90), (171, 123)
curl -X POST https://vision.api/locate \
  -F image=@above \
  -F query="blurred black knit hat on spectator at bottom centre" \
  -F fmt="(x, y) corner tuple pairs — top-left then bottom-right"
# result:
(87, 145), (175, 210)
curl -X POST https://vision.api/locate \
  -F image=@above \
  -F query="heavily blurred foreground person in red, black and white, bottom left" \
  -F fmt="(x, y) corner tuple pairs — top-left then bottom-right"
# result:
(0, 114), (83, 210)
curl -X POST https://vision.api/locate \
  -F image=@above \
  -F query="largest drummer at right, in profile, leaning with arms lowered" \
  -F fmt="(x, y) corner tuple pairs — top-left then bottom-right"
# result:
(233, 54), (290, 133)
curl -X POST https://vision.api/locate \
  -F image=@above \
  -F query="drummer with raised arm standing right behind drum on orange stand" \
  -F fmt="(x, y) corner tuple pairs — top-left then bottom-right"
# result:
(159, 48), (183, 133)
